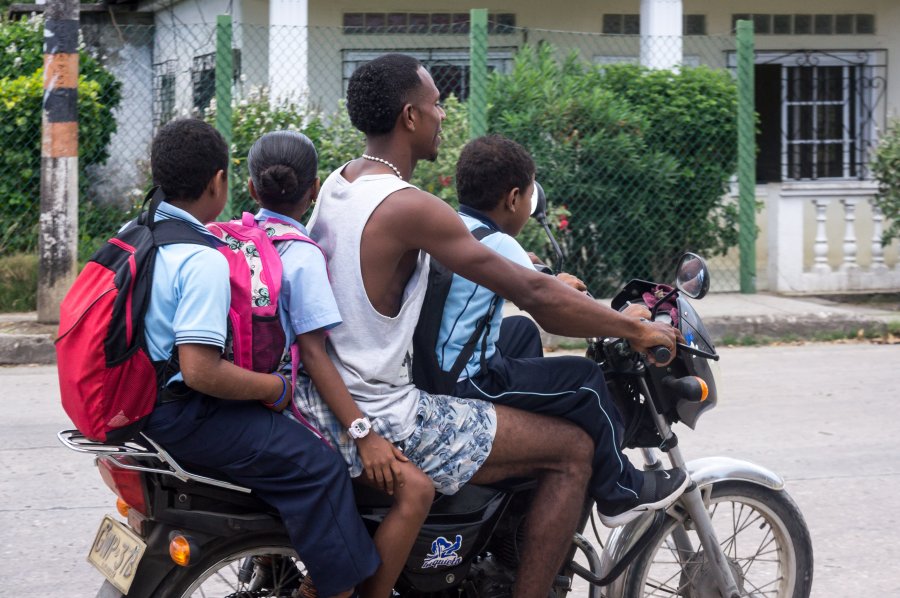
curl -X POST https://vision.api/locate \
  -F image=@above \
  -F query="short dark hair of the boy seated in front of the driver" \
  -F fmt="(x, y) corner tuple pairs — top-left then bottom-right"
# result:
(456, 135), (534, 210)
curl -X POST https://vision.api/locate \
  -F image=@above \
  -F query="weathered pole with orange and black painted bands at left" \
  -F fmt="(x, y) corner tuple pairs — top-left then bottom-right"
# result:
(37, 0), (78, 323)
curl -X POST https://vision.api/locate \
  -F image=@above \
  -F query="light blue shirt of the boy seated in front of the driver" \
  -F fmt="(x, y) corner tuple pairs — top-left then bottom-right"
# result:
(435, 214), (534, 380)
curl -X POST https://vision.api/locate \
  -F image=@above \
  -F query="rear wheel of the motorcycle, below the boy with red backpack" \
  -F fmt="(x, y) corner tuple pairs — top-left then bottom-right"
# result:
(156, 535), (306, 598)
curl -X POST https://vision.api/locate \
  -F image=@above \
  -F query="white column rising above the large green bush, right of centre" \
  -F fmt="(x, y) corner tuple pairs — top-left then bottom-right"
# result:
(641, 0), (684, 69)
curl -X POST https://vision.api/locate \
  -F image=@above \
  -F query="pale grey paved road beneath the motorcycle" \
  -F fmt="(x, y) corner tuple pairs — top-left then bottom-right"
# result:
(0, 344), (900, 598)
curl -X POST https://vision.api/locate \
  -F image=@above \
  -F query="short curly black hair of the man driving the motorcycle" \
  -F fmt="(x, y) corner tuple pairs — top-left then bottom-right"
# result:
(347, 54), (422, 135)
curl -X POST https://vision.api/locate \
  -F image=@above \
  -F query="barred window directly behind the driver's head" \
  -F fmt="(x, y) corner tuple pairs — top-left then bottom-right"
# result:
(343, 48), (516, 100)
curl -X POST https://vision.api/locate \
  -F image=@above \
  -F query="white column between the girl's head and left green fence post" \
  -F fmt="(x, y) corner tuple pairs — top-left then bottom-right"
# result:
(269, 0), (309, 103)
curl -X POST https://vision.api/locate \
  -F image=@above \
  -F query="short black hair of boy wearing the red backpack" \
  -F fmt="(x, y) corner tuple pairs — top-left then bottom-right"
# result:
(150, 118), (228, 201)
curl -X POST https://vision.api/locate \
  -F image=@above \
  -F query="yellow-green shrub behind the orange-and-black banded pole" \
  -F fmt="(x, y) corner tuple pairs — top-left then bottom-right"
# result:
(0, 17), (121, 253)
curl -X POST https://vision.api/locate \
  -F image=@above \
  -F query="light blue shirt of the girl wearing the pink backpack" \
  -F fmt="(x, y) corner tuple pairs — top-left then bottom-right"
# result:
(256, 208), (341, 344)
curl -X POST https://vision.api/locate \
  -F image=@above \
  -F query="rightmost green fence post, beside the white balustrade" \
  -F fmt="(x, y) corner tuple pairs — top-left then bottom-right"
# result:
(737, 21), (756, 293)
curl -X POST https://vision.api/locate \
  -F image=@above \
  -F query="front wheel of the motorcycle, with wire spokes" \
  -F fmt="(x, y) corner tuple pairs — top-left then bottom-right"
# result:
(625, 482), (813, 598)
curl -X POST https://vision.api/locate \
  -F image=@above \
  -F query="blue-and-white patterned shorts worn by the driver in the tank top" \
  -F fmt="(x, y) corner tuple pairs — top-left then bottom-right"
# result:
(398, 392), (497, 494)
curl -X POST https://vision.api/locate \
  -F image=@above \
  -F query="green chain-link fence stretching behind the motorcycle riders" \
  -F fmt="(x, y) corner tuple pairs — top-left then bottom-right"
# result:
(0, 13), (738, 294)
